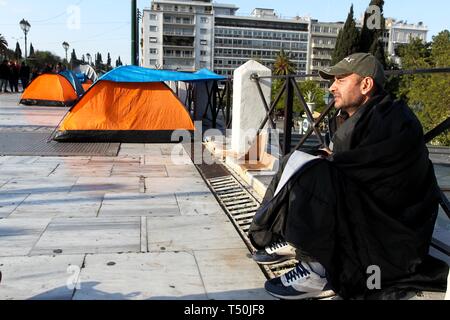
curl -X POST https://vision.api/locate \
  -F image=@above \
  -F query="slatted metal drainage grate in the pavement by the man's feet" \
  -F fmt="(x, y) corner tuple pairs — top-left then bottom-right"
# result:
(206, 175), (296, 279)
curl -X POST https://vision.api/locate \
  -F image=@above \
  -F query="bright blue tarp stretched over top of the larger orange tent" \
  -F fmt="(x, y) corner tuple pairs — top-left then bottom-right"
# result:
(99, 66), (226, 82)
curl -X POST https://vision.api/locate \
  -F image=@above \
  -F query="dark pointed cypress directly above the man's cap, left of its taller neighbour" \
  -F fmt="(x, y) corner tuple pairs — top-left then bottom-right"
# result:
(332, 5), (360, 65)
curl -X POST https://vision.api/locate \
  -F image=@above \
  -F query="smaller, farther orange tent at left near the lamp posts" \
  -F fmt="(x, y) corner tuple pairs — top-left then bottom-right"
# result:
(20, 74), (78, 106)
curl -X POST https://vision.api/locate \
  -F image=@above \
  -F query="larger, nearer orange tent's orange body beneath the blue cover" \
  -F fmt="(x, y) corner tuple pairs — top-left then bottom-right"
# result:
(55, 81), (195, 143)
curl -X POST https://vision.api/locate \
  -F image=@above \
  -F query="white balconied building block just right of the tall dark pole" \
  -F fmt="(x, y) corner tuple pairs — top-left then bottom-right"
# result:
(140, 0), (214, 71)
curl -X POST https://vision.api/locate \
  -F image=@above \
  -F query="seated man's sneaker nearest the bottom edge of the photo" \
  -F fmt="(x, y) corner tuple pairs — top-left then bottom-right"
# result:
(264, 262), (335, 300)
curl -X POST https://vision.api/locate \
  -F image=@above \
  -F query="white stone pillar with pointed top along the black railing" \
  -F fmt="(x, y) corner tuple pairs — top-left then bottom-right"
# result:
(231, 60), (272, 155)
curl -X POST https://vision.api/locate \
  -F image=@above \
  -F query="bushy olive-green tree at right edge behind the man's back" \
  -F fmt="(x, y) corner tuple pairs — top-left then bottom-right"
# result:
(399, 30), (450, 146)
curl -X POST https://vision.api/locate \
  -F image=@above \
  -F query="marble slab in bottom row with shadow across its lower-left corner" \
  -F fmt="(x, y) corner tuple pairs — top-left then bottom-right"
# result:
(74, 252), (206, 300)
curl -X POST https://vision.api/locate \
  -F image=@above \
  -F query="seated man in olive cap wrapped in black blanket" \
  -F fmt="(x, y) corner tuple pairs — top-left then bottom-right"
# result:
(249, 53), (448, 299)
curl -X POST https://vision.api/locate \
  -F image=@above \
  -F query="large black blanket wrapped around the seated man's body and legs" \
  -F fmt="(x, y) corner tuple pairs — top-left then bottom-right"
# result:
(249, 95), (446, 298)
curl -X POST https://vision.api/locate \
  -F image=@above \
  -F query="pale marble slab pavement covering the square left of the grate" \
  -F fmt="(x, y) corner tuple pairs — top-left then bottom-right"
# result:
(0, 94), (271, 300)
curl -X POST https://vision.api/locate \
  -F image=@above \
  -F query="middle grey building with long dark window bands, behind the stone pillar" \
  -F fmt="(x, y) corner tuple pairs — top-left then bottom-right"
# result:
(213, 5), (311, 75)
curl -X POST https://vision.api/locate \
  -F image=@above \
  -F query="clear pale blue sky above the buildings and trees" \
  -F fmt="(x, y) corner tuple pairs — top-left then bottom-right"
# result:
(0, 0), (450, 63)
